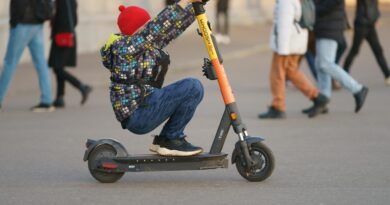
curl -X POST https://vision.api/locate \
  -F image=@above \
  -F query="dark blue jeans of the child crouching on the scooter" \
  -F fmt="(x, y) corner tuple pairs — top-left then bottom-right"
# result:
(126, 78), (203, 139)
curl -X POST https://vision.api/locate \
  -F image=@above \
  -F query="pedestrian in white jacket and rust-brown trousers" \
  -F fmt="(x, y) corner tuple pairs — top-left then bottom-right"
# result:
(258, 0), (328, 119)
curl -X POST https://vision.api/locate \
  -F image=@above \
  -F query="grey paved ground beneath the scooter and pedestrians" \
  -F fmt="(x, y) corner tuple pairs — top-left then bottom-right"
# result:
(0, 6), (390, 205)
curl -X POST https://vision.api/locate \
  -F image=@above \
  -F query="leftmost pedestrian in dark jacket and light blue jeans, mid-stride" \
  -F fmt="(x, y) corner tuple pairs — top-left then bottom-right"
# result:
(0, 0), (54, 112)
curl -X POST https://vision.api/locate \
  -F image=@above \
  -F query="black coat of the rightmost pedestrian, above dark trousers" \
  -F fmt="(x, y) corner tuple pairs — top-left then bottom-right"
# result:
(355, 0), (380, 26)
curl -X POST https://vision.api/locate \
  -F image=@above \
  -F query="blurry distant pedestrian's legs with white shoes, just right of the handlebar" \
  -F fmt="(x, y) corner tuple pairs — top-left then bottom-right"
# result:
(215, 0), (230, 44)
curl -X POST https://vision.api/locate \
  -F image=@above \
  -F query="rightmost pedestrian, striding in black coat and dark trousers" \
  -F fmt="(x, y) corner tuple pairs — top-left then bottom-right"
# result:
(344, 0), (390, 86)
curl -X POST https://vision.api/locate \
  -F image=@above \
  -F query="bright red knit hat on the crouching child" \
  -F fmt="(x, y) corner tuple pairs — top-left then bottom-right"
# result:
(117, 5), (150, 35)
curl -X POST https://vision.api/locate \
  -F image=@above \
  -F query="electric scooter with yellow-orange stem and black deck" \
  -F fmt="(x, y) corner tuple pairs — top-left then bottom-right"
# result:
(84, 0), (275, 183)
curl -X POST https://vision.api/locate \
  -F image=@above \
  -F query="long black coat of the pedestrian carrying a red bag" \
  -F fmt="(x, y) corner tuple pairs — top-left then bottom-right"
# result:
(49, 0), (77, 68)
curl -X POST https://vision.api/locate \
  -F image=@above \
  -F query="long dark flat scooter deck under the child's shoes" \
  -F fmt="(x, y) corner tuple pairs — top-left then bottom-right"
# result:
(98, 153), (228, 172)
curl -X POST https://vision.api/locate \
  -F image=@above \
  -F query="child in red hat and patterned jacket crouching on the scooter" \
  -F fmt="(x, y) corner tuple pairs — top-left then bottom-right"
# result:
(101, 0), (203, 156)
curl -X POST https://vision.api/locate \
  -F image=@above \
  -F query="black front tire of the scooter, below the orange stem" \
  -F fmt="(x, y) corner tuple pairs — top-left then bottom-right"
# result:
(234, 142), (275, 182)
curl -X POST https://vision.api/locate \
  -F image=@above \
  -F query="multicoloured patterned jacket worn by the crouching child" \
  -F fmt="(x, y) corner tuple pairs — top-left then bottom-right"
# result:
(100, 4), (195, 122)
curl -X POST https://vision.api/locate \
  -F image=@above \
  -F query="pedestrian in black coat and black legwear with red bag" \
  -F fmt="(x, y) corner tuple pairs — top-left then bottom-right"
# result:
(49, 0), (92, 108)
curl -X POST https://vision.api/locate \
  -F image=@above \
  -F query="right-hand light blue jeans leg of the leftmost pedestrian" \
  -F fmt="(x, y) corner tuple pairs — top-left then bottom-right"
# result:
(28, 24), (52, 104)
